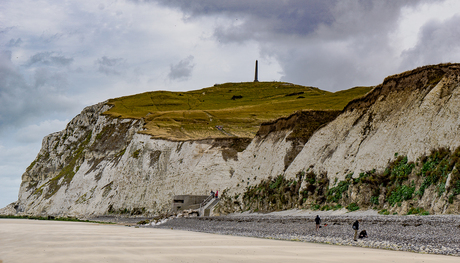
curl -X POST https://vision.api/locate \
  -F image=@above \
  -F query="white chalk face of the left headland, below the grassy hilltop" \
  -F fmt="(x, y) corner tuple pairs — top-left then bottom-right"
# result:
(17, 103), (291, 217)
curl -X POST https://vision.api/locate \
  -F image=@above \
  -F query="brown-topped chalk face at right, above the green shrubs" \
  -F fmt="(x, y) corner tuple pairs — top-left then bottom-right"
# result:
(286, 65), (460, 184)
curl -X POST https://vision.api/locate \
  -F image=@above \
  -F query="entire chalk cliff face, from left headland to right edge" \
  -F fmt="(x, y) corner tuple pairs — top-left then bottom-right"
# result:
(15, 64), (460, 217)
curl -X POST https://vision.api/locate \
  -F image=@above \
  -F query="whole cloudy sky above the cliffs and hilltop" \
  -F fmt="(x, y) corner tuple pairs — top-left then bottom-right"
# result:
(0, 0), (460, 208)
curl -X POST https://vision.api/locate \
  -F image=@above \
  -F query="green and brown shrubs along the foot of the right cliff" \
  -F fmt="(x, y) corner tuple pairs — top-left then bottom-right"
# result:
(217, 147), (460, 215)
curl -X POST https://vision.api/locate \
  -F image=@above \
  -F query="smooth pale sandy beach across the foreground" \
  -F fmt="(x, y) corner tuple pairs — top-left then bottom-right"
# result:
(0, 219), (458, 263)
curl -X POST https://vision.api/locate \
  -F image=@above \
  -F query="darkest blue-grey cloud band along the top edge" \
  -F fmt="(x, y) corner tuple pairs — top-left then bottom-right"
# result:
(143, 0), (432, 42)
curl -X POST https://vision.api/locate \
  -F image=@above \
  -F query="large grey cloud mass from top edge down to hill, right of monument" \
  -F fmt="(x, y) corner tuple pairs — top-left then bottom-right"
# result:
(142, 0), (436, 91)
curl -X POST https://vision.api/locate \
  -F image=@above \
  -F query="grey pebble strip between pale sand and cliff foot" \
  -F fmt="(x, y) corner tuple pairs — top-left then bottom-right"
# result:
(152, 214), (460, 257)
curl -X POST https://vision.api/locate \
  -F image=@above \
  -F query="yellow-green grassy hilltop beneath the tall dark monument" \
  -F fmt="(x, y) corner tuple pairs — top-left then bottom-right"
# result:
(105, 82), (372, 140)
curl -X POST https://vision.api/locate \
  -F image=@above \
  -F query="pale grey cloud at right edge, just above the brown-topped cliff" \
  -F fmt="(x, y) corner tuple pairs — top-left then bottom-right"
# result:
(401, 15), (460, 70)
